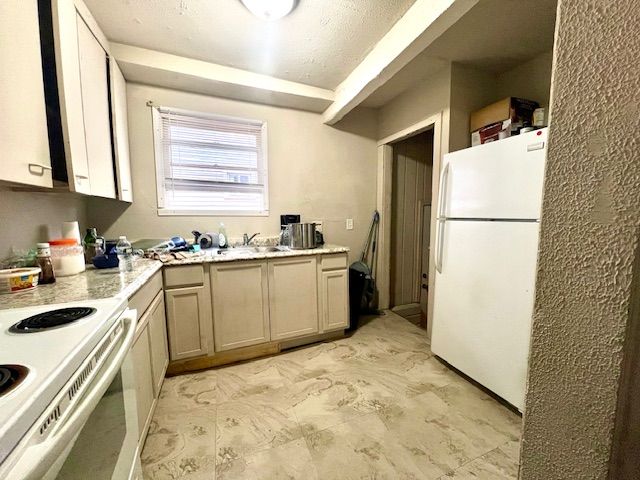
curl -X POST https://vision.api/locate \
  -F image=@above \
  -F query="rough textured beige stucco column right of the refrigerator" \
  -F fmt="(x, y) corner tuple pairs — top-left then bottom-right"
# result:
(520, 0), (640, 480)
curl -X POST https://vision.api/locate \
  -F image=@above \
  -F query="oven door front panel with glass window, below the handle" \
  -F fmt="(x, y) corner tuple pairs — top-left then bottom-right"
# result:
(44, 344), (140, 480)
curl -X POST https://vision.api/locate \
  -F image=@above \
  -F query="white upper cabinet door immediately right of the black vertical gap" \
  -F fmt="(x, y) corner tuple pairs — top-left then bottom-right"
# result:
(51, 0), (91, 194)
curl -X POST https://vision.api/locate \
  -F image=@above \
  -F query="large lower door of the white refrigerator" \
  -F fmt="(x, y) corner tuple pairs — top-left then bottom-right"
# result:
(431, 220), (539, 410)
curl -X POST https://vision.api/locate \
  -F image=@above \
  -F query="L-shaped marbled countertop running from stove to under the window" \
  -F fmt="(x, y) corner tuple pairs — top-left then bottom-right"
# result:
(0, 245), (349, 310)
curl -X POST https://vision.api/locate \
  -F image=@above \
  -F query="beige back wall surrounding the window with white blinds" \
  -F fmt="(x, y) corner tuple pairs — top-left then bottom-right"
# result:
(89, 84), (377, 259)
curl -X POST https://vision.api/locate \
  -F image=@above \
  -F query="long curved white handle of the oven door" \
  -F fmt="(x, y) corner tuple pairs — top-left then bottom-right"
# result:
(9, 309), (137, 480)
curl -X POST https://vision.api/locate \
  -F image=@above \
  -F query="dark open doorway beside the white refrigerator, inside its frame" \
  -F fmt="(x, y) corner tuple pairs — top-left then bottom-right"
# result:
(390, 128), (434, 328)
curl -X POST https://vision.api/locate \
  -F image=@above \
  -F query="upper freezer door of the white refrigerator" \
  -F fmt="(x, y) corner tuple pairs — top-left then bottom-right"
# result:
(438, 129), (547, 219)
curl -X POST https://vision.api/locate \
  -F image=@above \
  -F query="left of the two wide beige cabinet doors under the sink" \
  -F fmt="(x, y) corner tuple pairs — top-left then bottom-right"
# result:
(211, 262), (269, 352)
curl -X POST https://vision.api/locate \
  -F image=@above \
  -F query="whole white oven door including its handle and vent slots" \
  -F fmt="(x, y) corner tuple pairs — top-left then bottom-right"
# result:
(0, 310), (141, 480)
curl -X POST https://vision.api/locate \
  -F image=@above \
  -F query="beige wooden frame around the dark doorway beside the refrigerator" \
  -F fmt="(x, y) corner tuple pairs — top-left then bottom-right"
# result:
(376, 111), (448, 339)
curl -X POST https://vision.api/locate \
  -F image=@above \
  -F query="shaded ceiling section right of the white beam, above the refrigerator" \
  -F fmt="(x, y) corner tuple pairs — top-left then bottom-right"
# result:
(364, 0), (557, 107)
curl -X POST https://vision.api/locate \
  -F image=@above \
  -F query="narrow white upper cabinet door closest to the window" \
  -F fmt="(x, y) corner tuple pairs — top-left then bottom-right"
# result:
(109, 58), (133, 202)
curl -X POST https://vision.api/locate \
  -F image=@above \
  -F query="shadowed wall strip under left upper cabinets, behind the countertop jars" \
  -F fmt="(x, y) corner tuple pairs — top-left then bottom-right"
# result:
(0, 188), (87, 258)
